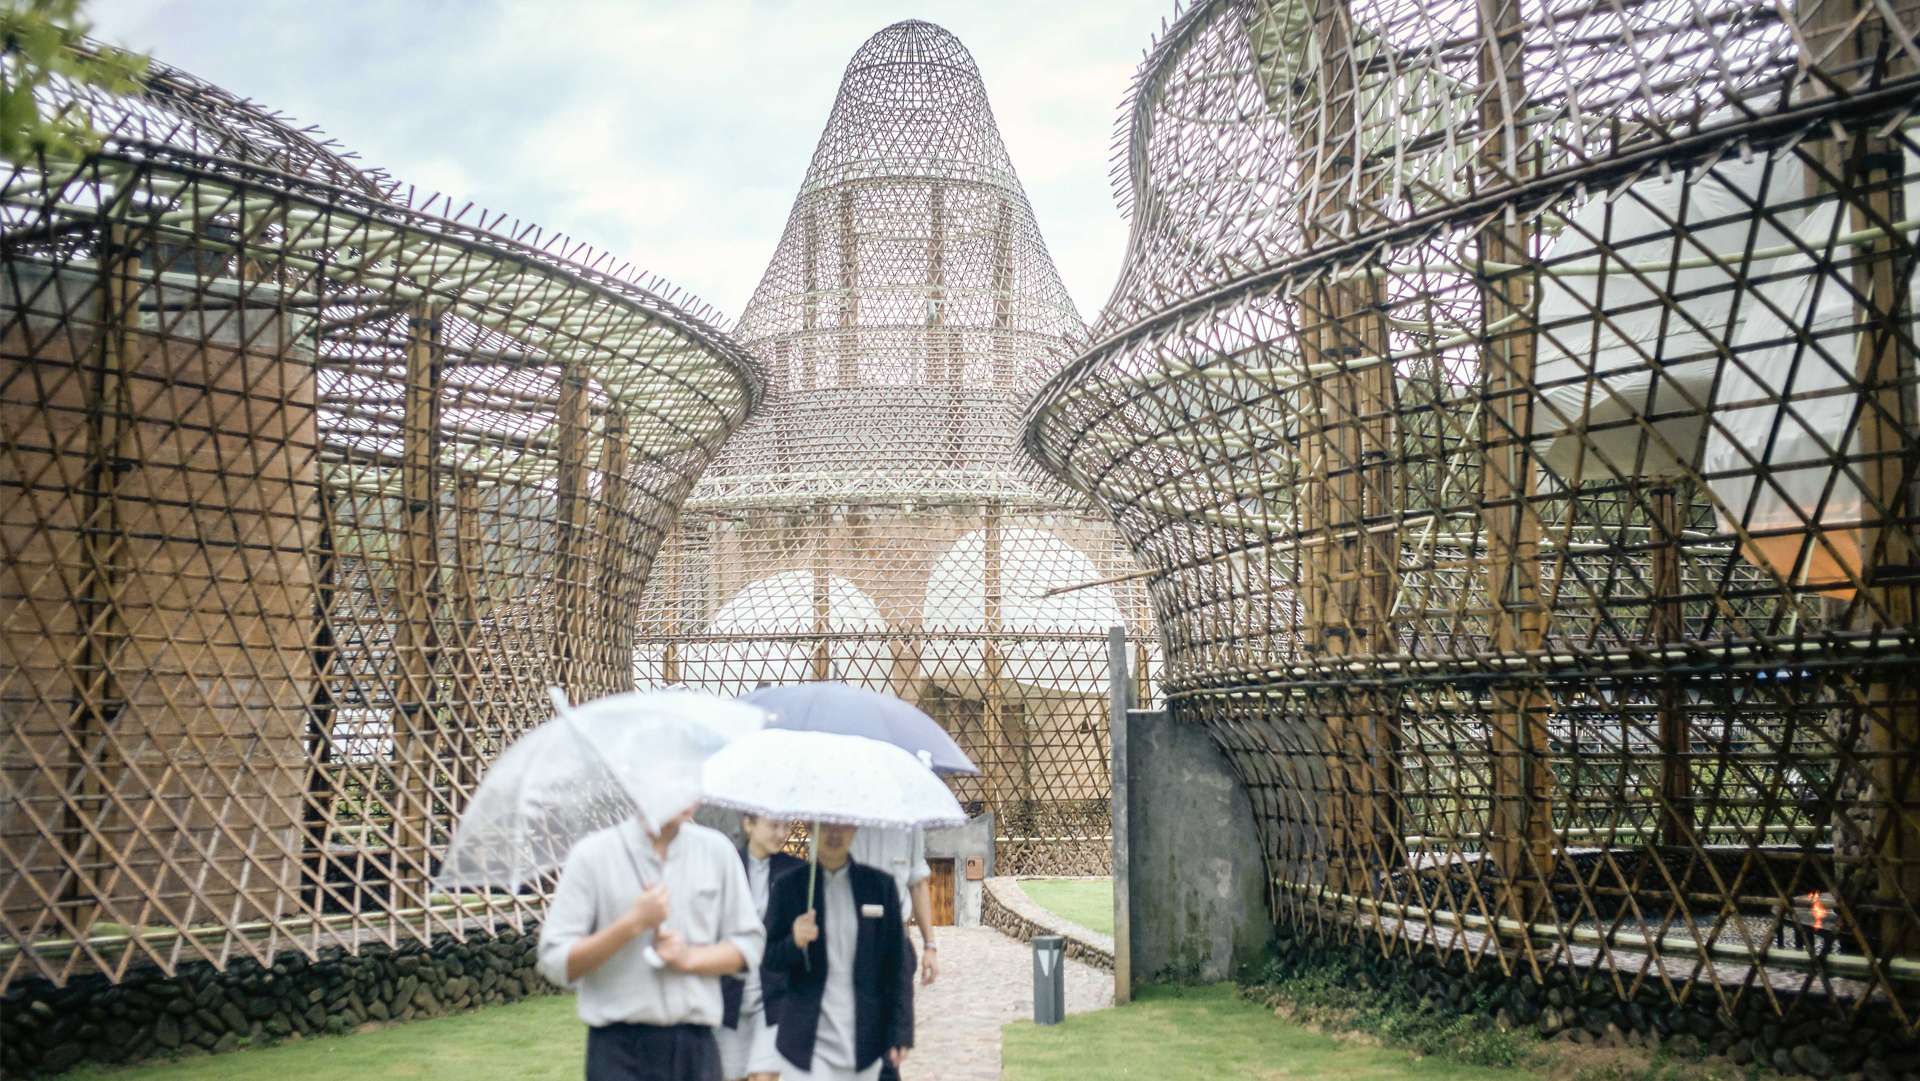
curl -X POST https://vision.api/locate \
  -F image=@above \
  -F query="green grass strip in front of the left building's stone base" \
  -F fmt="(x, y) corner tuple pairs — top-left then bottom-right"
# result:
(63, 995), (588, 1081)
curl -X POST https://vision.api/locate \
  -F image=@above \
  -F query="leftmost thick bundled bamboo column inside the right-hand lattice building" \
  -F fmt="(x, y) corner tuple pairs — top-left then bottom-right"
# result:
(1300, 0), (1400, 891)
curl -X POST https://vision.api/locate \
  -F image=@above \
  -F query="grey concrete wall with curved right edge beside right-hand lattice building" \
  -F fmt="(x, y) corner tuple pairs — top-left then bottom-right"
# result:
(1114, 710), (1273, 997)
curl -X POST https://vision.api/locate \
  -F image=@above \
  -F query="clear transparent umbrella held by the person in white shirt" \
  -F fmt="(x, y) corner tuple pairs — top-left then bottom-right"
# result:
(434, 689), (772, 889)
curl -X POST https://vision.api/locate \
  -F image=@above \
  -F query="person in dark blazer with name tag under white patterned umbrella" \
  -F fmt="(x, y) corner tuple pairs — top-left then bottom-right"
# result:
(760, 826), (914, 1081)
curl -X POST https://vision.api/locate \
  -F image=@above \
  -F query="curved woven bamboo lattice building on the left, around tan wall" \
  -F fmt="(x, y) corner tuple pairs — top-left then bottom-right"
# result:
(0, 52), (760, 985)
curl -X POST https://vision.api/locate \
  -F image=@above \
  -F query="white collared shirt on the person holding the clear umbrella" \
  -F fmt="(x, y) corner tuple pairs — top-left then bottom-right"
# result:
(540, 822), (766, 1027)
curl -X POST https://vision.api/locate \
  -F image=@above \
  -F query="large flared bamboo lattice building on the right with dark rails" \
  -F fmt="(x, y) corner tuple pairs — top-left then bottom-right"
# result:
(1027, 0), (1920, 1025)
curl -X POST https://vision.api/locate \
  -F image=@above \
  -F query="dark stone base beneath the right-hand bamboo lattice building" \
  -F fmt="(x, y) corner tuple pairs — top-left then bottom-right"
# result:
(1256, 929), (1920, 1081)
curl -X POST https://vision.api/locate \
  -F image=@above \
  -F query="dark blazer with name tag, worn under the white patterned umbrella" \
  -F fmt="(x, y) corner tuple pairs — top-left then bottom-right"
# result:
(760, 864), (914, 1069)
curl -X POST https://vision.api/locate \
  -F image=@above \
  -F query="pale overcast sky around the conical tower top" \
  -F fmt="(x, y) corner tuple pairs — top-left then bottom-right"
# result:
(86, 0), (1173, 321)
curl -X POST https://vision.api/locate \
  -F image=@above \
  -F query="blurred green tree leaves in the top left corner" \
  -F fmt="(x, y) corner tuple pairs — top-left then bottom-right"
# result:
(0, 0), (148, 161)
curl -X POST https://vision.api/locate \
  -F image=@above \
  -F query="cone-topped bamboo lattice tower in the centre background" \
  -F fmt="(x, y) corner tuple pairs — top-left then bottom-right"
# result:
(637, 21), (1150, 874)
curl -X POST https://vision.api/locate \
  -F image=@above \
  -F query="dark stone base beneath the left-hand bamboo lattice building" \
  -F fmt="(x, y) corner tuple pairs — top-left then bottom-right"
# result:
(0, 931), (555, 1077)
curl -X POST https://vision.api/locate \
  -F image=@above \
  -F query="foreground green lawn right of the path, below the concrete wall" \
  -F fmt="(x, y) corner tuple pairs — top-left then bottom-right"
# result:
(1000, 983), (1538, 1081)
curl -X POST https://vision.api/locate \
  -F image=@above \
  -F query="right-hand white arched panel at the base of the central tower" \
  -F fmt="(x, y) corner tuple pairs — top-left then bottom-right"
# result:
(922, 528), (1123, 695)
